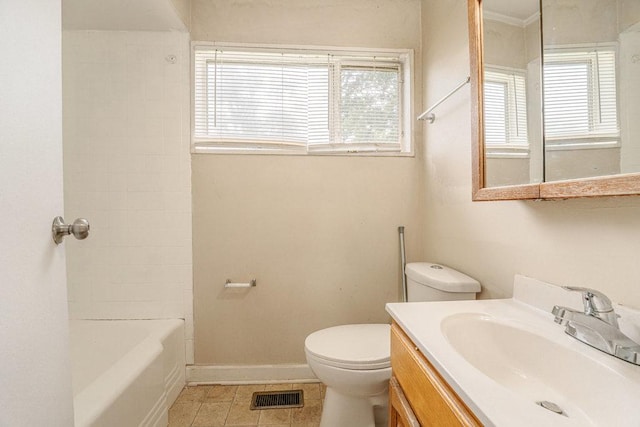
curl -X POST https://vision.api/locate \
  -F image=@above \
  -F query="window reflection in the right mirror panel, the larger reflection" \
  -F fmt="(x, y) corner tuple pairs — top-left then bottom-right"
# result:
(543, 46), (620, 145)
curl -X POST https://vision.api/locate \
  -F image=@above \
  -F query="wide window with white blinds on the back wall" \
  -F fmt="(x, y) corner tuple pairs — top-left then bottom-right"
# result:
(192, 45), (411, 154)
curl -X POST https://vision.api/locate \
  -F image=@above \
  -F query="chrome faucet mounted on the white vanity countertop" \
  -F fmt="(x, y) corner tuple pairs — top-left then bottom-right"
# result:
(551, 286), (640, 365)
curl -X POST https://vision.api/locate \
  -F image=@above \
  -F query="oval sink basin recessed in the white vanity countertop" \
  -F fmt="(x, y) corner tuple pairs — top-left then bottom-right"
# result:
(440, 313), (638, 426)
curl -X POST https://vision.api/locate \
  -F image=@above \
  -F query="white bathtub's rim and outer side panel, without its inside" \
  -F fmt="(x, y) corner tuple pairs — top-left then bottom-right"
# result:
(74, 319), (186, 427)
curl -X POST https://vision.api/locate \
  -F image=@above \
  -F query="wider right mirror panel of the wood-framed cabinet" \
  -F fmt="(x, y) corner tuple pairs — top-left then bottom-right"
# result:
(542, 0), (640, 182)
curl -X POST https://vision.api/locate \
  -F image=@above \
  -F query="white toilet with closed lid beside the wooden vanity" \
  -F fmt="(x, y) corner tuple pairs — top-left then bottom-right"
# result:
(304, 262), (480, 427)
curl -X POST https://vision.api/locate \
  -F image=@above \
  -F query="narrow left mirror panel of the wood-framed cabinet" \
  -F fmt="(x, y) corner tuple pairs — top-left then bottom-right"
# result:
(482, 0), (543, 187)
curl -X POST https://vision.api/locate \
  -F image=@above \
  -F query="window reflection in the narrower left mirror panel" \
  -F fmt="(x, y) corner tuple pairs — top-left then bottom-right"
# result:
(483, 67), (529, 149)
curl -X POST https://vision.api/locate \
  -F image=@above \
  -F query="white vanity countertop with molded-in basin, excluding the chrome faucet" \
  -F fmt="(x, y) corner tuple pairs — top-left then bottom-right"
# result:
(387, 276), (640, 427)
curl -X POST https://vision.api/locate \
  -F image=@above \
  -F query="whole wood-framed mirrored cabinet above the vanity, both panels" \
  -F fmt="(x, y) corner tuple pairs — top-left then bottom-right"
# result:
(468, 0), (640, 200)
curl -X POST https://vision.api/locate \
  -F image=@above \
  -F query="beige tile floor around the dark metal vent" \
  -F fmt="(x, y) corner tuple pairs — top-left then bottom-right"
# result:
(169, 383), (325, 427)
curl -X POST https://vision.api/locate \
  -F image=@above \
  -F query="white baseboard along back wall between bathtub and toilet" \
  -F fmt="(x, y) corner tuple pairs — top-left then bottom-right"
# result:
(187, 364), (318, 385)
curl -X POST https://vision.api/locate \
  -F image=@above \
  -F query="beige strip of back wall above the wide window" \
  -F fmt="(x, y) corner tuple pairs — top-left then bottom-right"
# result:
(191, 0), (420, 49)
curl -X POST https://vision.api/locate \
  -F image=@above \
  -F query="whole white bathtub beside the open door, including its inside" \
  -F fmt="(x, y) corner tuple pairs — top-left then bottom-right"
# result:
(70, 319), (185, 427)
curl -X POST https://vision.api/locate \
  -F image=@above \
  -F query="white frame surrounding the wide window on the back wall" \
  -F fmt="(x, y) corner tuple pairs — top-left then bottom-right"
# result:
(190, 41), (415, 157)
